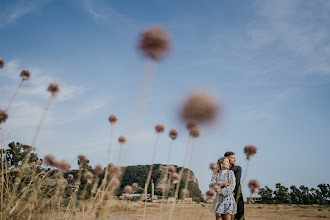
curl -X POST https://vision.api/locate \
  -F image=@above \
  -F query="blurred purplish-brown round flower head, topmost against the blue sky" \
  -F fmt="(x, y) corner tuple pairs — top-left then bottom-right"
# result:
(139, 27), (169, 60)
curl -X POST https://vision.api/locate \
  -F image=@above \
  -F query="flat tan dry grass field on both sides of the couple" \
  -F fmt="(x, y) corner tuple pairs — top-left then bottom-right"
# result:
(103, 203), (330, 220)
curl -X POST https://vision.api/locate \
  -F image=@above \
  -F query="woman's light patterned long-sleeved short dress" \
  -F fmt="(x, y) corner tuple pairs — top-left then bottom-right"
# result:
(210, 170), (237, 216)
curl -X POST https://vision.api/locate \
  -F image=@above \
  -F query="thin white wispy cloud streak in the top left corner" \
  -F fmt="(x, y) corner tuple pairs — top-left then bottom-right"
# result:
(0, 0), (50, 28)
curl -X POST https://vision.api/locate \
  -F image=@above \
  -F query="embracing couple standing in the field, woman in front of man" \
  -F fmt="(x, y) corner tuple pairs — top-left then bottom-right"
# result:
(210, 151), (244, 220)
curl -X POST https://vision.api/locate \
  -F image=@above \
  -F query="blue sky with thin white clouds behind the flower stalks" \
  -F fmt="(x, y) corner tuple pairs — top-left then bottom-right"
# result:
(0, 0), (330, 197)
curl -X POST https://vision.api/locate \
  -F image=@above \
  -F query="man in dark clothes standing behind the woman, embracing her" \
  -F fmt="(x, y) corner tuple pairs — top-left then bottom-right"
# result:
(224, 151), (244, 220)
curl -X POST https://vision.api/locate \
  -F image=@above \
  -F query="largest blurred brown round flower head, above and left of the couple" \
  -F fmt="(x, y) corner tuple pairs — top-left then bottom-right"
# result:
(181, 92), (218, 123)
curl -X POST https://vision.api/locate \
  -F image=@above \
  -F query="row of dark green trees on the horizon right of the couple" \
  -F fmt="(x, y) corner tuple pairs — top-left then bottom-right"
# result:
(258, 183), (330, 205)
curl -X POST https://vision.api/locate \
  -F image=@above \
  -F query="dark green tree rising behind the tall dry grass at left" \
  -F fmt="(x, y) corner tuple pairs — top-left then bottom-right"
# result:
(6, 142), (41, 167)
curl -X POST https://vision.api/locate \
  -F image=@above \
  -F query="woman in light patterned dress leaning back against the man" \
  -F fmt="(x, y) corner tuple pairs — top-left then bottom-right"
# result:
(210, 157), (237, 220)
